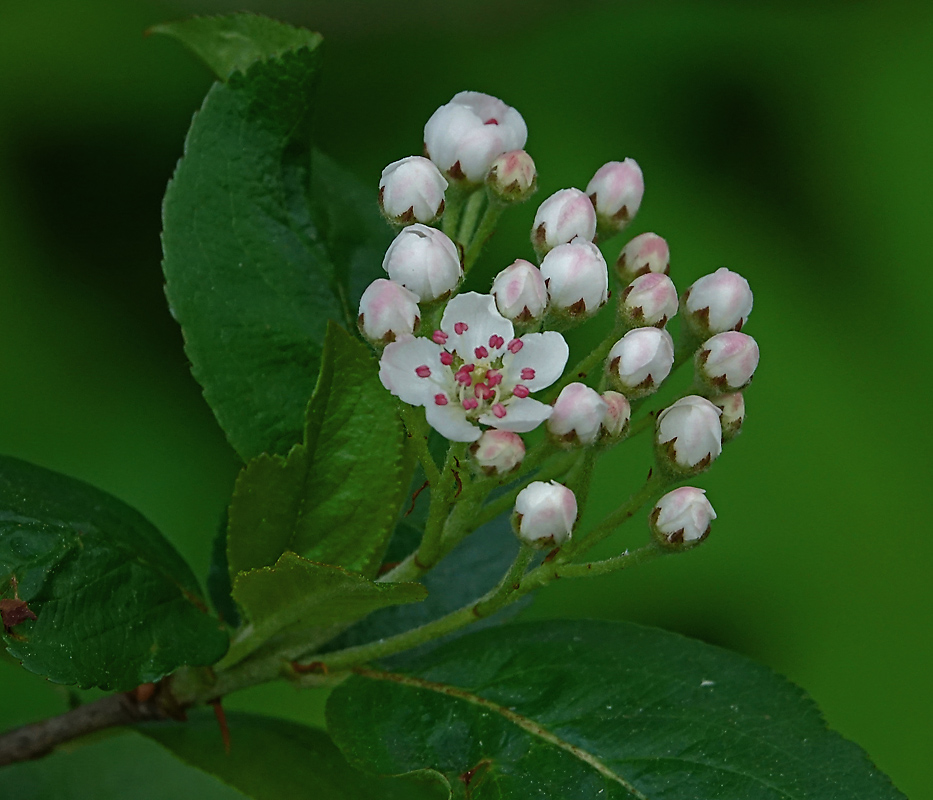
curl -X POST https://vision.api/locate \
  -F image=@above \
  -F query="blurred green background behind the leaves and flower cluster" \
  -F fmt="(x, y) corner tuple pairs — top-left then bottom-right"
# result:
(0, 0), (933, 800)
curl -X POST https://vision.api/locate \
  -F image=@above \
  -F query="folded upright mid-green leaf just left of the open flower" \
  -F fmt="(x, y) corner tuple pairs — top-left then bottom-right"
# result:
(227, 324), (413, 576)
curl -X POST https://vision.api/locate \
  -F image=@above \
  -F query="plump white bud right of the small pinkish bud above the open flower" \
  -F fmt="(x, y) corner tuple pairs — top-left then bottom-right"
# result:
(541, 239), (609, 317)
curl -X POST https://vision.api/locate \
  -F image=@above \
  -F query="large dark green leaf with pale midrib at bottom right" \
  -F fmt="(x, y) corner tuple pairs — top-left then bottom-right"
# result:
(327, 621), (903, 800)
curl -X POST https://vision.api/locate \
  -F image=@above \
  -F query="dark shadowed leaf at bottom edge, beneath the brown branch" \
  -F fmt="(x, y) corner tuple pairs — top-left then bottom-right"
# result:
(137, 711), (443, 800)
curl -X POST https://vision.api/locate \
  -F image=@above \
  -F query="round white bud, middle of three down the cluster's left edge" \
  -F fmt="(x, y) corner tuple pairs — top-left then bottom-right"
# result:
(382, 223), (463, 303)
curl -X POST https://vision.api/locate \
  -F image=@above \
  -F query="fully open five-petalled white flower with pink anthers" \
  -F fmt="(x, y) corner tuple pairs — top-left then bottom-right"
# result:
(379, 292), (569, 442)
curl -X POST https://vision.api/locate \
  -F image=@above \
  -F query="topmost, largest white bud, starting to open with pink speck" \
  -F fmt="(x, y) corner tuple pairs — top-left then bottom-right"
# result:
(424, 92), (528, 184)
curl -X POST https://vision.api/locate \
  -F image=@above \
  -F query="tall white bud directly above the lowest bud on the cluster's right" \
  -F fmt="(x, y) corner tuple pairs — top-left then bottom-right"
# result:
(655, 394), (722, 475)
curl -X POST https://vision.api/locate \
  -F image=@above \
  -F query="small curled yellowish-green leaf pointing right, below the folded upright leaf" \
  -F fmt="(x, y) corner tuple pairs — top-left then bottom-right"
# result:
(223, 553), (427, 667)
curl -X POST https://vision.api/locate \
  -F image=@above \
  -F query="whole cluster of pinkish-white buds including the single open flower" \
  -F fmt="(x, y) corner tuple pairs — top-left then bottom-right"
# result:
(359, 92), (758, 547)
